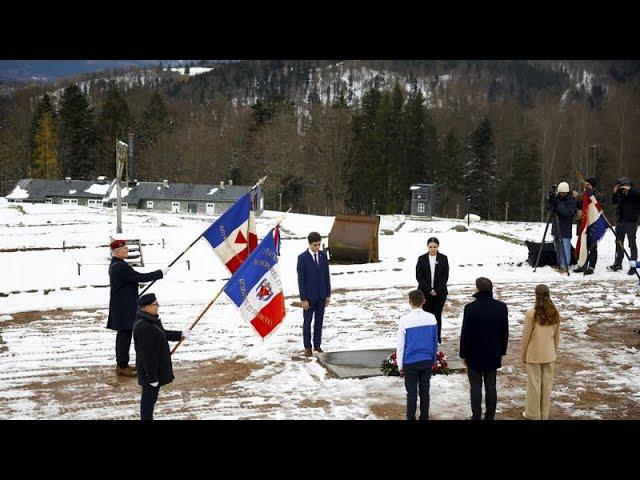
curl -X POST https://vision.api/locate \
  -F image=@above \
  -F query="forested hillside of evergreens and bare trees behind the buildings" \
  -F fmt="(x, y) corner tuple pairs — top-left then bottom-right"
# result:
(0, 61), (640, 220)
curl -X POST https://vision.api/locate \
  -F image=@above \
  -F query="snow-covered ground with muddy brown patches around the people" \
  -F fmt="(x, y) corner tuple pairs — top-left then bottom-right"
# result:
(0, 199), (640, 419)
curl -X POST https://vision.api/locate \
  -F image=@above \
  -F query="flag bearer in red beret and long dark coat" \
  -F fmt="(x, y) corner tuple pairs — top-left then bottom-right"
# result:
(107, 240), (169, 377)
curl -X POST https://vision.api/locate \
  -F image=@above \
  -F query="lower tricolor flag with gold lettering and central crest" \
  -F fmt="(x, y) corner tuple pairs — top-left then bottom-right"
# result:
(224, 227), (286, 339)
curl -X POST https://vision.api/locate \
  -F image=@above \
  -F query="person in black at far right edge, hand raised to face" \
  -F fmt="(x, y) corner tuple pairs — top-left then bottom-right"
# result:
(609, 177), (640, 275)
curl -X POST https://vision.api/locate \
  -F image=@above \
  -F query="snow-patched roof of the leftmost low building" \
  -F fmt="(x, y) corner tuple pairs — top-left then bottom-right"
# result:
(7, 178), (109, 202)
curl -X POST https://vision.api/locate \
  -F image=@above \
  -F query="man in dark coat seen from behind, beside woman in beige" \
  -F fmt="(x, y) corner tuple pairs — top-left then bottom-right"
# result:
(460, 277), (509, 420)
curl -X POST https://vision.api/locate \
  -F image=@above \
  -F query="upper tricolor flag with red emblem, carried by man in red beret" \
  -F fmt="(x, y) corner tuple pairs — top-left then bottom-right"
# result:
(202, 192), (258, 273)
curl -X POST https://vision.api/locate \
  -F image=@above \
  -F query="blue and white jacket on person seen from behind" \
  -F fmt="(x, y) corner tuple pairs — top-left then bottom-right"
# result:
(396, 308), (438, 370)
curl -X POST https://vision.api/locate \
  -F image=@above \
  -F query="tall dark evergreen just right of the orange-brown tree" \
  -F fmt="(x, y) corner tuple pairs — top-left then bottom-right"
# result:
(60, 84), (98, 179)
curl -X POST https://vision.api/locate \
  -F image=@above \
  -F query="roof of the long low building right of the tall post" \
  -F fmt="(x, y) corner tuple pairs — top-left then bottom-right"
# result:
(104, 182), (251, 204)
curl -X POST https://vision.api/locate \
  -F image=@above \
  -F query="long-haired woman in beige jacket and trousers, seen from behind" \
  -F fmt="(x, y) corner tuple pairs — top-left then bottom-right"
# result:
(522, 285), (560, 420)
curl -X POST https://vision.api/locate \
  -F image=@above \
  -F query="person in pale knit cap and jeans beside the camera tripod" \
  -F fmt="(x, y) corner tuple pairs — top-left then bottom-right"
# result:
(547, 182), (576, 273)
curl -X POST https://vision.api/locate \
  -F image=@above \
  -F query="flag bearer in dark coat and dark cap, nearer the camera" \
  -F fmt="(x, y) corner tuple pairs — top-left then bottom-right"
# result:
(133, 293), (191, 420)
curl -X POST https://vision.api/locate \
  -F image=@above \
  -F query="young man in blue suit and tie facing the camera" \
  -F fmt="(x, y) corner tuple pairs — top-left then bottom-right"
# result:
(297, 232), (331, 357)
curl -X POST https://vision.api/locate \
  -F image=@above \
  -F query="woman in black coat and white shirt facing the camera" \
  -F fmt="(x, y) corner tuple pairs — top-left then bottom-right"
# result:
(416, 237), (449, 343)
